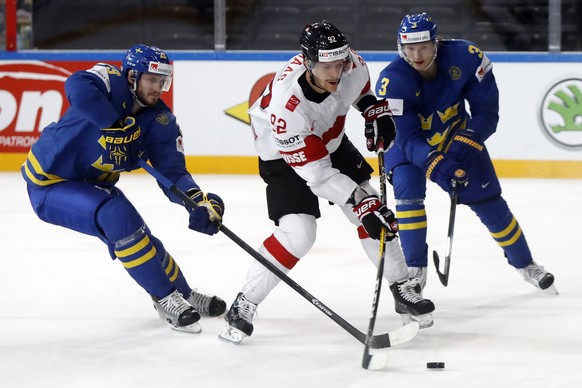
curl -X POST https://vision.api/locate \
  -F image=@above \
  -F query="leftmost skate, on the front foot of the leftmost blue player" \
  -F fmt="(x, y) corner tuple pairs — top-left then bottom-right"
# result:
(152, 290), (202, 334)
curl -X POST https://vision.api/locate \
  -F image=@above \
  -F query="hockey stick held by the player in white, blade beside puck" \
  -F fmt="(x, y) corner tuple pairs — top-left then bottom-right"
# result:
(362, 151), (388, 370)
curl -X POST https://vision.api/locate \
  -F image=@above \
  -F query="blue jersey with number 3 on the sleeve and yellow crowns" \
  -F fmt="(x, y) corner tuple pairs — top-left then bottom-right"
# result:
(376, 40), (499, 170)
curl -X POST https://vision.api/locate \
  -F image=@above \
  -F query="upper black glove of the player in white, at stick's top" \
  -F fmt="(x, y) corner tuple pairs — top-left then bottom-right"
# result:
(362, 100), (396, 152)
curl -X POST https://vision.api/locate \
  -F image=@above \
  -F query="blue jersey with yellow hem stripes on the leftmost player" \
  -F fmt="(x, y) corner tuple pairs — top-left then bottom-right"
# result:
(22, 63), (197, 200)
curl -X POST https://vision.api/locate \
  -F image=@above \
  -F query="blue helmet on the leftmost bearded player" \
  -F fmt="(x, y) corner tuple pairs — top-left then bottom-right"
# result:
(121, 44), (173, 91)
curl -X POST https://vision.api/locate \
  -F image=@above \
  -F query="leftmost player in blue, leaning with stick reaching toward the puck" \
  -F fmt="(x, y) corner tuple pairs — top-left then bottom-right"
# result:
(22, 44), (226, 333)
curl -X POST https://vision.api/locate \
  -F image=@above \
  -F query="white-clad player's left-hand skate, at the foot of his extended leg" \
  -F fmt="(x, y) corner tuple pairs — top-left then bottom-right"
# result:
(218, 292), (257, 345)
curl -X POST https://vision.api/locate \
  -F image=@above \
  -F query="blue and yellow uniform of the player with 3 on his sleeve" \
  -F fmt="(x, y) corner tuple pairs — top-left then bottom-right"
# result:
(376, 40), (532, 268)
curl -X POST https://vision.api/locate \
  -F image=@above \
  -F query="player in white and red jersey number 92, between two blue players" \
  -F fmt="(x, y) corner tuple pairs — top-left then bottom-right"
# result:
(220, 21), (434, 343)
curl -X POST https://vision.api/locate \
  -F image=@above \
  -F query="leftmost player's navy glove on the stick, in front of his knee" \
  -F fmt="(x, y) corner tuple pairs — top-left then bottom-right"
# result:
(187, 188), (224, 235)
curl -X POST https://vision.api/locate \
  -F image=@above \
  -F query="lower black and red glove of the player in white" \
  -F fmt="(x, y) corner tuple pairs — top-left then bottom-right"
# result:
(352, 195), (398, 240)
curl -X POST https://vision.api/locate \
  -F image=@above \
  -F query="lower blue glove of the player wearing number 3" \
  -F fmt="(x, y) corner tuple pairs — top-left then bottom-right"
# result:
(424, 150), (468, 194)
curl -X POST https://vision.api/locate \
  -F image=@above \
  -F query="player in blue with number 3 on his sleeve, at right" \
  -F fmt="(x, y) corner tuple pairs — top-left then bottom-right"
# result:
(367, 13), (557, 294)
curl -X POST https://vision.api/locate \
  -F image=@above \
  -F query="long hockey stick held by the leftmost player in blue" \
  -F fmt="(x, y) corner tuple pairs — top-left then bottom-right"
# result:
(138, 159), (418, 349)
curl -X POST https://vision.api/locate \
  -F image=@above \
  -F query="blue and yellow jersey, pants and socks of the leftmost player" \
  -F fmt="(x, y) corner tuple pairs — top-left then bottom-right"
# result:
(22, 63), (198, 298)
